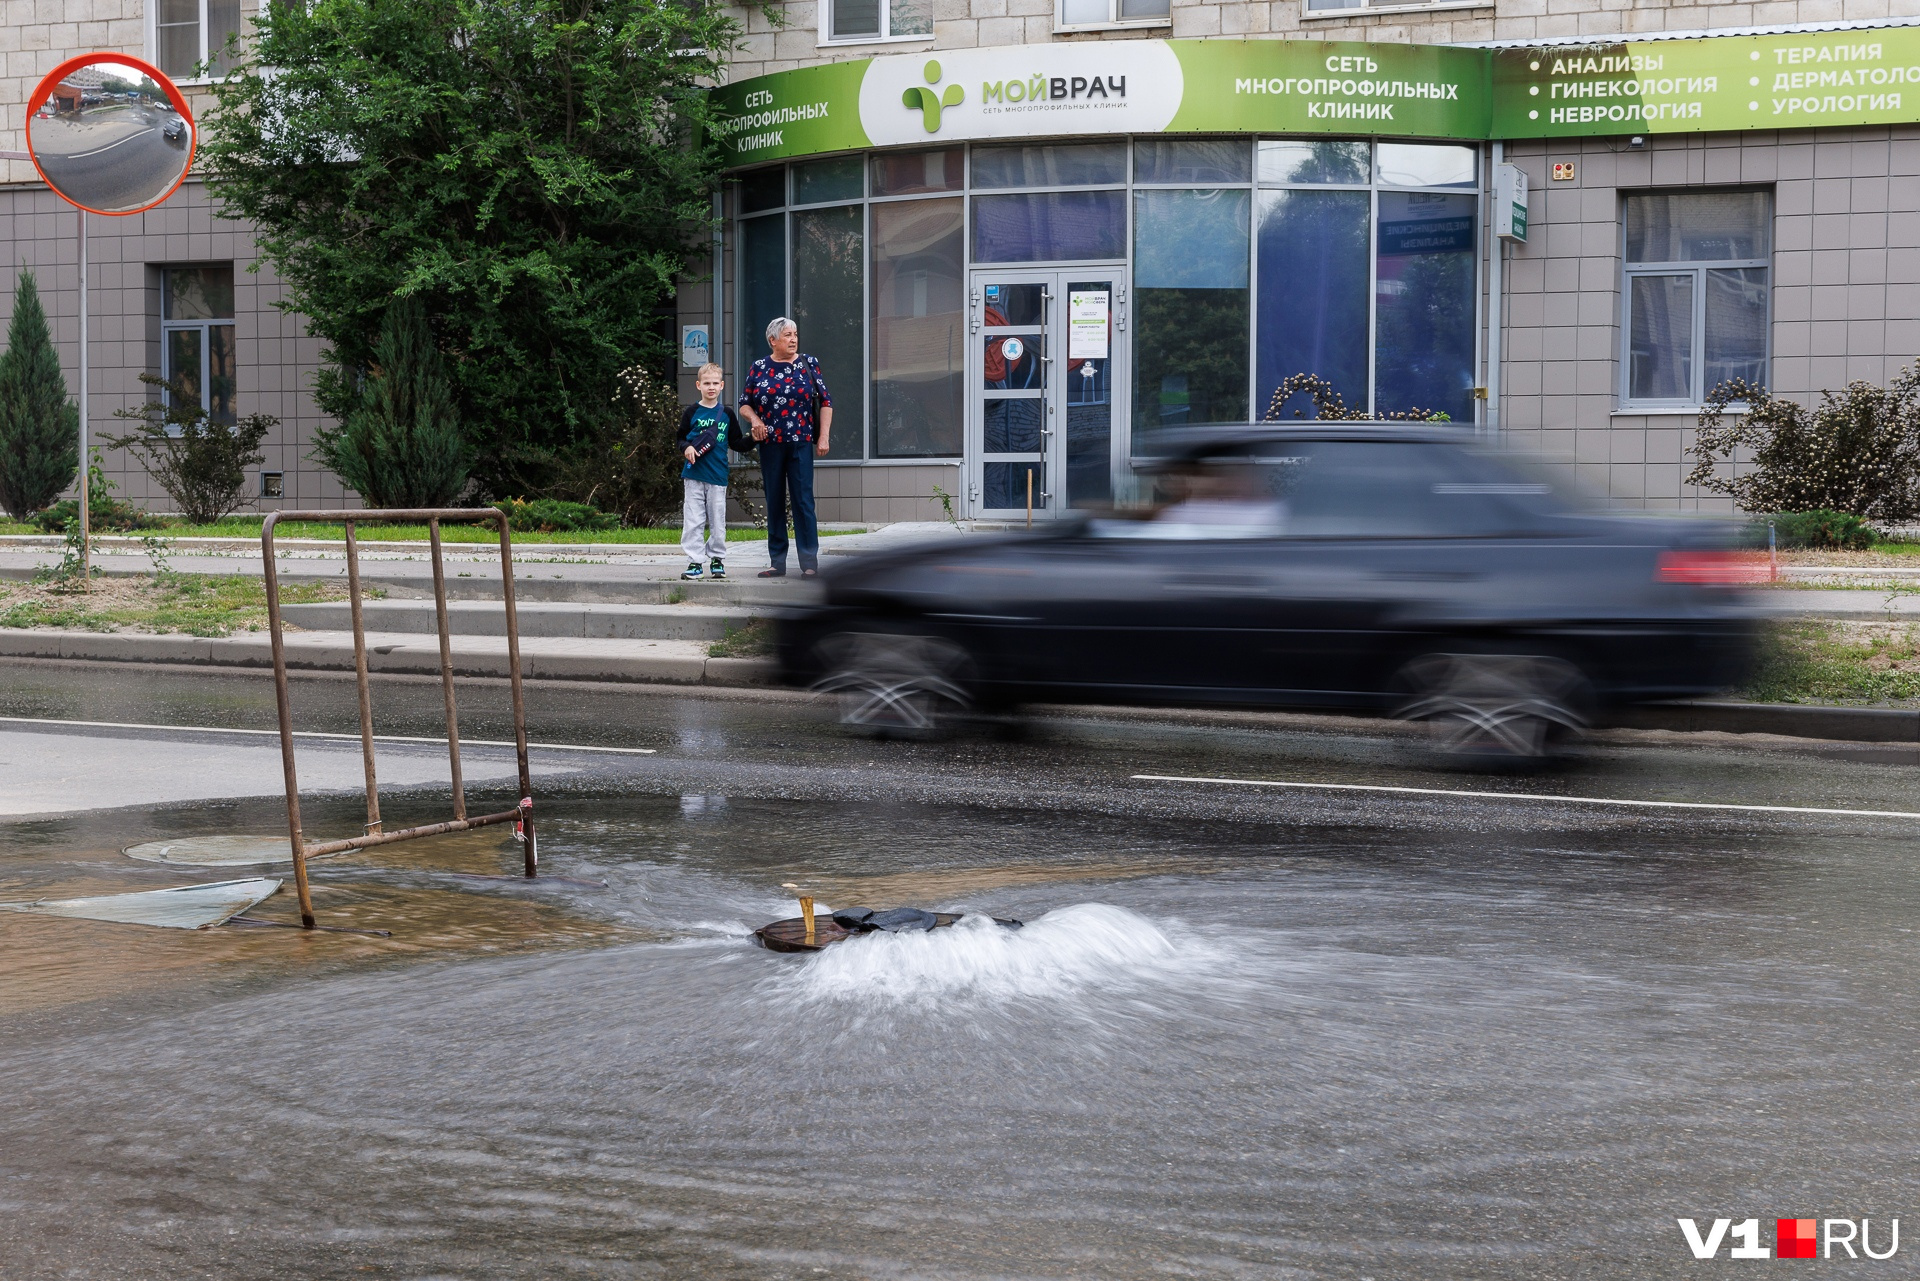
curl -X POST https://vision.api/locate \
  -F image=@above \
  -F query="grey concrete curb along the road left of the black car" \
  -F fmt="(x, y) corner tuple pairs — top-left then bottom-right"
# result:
(0, 628), (776, 688)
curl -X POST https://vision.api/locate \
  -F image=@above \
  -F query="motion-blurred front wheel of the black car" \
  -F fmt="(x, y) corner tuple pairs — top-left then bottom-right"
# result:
(812, 628), (973, 737)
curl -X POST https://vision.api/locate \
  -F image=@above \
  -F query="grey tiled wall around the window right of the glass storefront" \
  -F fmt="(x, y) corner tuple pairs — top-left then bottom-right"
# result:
(1501, 127), (1920, 511)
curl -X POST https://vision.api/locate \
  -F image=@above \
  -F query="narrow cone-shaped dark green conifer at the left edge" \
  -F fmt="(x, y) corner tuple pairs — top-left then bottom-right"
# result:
(0, 271), (81, 520)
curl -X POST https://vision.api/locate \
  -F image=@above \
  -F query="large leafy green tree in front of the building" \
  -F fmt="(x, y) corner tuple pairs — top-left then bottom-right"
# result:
(200, 0), (741, 495)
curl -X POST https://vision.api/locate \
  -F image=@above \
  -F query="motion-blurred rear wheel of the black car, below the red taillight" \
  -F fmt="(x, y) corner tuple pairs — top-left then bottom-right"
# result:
(1394, 653), (1592, 761)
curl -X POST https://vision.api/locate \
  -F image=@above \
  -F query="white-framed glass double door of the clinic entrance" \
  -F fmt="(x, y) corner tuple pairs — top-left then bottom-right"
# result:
(968, 269), (1117, 520)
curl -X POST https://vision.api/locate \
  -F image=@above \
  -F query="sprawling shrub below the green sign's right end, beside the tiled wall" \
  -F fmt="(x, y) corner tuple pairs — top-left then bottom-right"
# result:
(1688, 365), (1920, 520)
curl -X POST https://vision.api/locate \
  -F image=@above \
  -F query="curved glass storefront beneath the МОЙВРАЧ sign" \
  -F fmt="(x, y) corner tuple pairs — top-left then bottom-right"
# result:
(732, 136), (1480, 501)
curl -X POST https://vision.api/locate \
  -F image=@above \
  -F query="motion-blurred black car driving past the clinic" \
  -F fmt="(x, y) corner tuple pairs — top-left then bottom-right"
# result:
(780, 424), (1766, 757)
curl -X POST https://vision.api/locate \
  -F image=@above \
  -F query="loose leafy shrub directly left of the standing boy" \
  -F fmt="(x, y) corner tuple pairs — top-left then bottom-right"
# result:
(545, 365), (685, 526)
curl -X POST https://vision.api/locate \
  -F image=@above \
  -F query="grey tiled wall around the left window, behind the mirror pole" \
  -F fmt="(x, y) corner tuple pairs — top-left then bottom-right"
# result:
(0, 182), (345, 511)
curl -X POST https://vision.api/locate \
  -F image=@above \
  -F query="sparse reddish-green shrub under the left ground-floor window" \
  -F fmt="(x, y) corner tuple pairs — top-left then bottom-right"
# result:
(107, 375), (280, 524)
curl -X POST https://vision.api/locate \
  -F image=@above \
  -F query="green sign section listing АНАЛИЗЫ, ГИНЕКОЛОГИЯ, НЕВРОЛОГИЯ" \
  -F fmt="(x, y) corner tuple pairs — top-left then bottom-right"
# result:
(1492, 27), (1920, 138)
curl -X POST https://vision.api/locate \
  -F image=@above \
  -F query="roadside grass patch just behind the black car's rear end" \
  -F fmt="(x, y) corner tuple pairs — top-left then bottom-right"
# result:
(1740, 618), (1920, 703)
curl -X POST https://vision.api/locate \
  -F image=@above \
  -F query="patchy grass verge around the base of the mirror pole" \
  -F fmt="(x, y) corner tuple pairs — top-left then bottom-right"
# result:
(0, 574), (359, 638)
